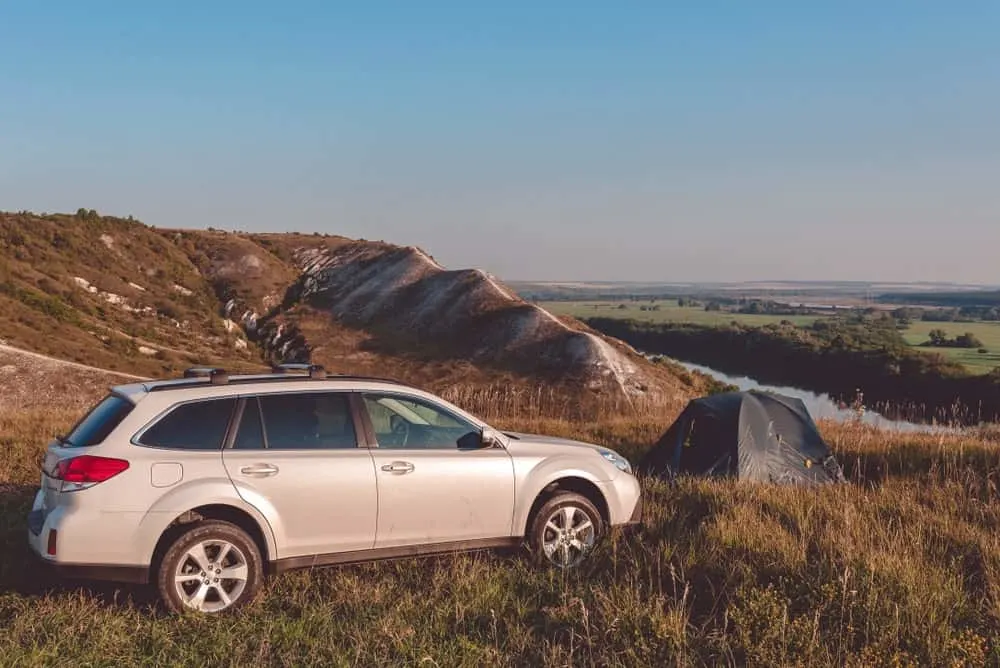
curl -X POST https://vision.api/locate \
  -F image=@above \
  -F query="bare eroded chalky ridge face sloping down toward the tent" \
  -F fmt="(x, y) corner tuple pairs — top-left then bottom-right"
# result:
(278, 242), (649, 395)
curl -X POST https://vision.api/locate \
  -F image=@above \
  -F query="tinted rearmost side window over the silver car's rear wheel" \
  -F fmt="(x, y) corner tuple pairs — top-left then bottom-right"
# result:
(139, 399), (236, 450)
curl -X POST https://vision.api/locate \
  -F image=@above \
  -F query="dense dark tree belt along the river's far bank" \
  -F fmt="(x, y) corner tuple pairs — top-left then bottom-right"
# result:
(587, 315), (1000, 423)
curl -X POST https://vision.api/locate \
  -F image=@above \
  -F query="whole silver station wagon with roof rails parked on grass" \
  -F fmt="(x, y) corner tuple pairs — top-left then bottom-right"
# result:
(28, 365), (641, 613)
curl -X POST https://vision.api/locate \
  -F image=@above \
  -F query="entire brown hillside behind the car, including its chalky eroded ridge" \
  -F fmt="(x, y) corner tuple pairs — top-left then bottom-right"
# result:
(0, 210), (708, 414)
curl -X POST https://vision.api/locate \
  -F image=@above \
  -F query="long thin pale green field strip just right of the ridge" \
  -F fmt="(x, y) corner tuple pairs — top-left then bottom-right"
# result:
(540, 299), (817, 326)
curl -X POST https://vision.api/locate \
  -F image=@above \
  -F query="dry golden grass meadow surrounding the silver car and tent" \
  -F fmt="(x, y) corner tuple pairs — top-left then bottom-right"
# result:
(0, 390), (1000, 666)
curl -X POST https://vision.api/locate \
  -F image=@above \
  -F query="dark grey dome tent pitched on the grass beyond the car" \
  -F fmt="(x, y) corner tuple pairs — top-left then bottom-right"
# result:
(638, 391), (844, 485)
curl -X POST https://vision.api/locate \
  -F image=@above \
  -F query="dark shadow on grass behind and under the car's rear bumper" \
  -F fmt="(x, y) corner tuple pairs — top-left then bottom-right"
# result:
(0, 485), (156, 608)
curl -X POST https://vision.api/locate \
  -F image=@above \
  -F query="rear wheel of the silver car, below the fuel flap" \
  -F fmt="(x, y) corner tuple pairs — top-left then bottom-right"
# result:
(156, 520), (264, 614)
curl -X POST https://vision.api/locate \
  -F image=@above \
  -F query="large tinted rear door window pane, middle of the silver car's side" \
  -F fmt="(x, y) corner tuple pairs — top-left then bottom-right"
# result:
(259, 392), (358, 450)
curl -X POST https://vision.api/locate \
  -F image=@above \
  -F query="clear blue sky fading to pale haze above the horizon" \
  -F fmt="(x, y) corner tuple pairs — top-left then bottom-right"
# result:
(0, 0), (1000, 284)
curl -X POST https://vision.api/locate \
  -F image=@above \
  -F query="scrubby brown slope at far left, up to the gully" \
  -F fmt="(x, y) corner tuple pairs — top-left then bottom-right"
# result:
(0, 212), (259, 375)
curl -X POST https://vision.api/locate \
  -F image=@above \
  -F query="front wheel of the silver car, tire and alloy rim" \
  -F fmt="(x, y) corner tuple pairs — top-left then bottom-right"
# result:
(528, 492), (604, 569)
